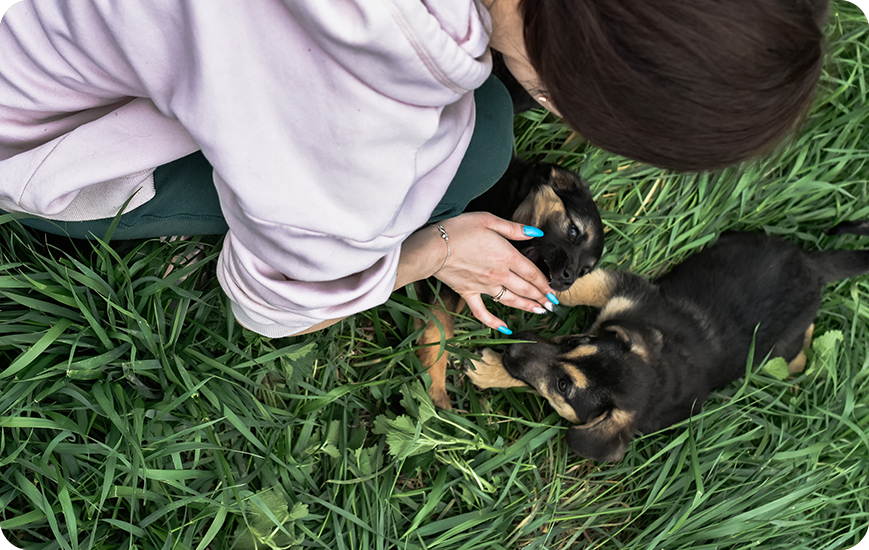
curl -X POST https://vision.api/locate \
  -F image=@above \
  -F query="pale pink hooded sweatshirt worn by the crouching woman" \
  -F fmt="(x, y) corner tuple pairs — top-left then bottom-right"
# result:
(0, 0), (491, 337)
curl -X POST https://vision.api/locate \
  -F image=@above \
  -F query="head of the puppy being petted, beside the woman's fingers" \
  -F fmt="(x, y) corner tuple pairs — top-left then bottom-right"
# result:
(512, 164), (604, 291)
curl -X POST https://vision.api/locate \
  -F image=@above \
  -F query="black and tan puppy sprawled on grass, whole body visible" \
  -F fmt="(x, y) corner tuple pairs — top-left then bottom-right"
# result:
(468, 227), (869, 461)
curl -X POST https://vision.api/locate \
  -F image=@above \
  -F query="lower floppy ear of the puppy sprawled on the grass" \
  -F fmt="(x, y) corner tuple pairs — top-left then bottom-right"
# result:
(567, 409), (634, 462)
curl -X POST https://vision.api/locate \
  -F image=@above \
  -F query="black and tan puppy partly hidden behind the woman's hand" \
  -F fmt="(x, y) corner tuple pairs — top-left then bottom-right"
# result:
(416, 159), (603, 409)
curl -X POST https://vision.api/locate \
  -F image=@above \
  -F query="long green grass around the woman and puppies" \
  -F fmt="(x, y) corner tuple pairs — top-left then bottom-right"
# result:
(0, 2), (869, 550)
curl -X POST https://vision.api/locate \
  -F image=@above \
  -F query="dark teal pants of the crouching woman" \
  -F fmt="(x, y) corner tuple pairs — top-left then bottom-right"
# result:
(8, 76), (513, 239)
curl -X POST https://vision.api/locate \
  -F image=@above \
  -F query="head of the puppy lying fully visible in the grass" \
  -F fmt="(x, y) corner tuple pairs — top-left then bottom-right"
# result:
(503, 322), (662, 461)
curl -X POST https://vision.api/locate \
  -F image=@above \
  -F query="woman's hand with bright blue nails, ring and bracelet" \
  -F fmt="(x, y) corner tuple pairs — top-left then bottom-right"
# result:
(396, 212), (556, 334)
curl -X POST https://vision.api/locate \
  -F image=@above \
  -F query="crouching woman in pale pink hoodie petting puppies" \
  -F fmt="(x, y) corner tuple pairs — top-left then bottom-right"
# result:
(0, 0), (826, 337)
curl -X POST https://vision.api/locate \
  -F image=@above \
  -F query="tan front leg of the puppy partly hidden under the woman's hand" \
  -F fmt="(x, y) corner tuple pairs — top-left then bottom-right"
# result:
(416, 289), (465, 410)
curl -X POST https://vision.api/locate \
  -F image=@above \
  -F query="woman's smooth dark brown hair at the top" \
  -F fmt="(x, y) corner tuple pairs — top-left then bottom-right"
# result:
(519, 0), (828, 171)
